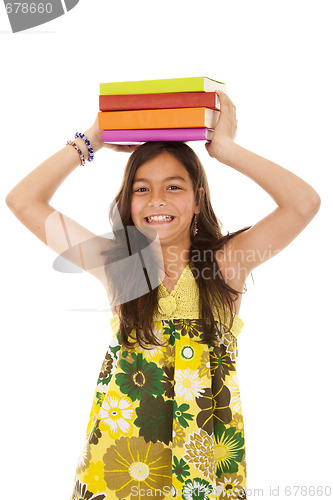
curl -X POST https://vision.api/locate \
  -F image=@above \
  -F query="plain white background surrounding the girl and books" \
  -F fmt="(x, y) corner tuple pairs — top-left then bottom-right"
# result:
(0, 0), (333, 500)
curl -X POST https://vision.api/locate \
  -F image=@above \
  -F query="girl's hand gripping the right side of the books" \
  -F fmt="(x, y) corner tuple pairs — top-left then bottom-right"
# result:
(205, 90), (237, 159)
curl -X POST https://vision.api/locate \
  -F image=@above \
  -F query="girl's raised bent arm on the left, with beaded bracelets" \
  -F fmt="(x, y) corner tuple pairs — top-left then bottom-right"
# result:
(6, 113), (137, 285)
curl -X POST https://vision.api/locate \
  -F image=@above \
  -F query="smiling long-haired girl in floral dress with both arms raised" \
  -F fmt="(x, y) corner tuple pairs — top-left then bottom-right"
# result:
(6, 92), (320, 500)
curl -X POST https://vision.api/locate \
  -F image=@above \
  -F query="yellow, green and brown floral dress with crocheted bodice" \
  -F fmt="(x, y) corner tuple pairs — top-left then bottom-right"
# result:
(70, 262), (246, 500)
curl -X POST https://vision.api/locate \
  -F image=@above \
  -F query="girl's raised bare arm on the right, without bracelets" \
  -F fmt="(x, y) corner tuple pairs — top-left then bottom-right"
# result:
(206, 91), (321, 281)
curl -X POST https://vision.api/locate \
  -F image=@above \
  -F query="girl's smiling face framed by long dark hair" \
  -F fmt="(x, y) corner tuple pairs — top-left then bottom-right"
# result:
(131, 152), (199, 246)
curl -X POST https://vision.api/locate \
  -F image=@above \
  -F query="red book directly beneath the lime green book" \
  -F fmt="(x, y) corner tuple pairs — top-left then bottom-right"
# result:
(99, 92), (220, 111)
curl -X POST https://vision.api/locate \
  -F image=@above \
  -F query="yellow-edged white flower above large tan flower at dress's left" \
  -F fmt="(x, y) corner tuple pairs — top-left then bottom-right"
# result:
(99, 391), (135, 439)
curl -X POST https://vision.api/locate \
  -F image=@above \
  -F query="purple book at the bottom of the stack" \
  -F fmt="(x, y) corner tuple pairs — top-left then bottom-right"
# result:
(102, 128), (214, 144)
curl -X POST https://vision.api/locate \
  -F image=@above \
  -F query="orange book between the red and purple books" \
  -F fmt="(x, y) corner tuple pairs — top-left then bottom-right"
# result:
(98, 108), (220, 130)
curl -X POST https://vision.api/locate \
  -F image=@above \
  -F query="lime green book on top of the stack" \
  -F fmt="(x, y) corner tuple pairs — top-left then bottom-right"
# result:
(100, 76), (226, 95)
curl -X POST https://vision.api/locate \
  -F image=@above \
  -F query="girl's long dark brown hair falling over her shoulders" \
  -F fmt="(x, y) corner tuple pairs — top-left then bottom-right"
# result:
(102, 142), (251, 348)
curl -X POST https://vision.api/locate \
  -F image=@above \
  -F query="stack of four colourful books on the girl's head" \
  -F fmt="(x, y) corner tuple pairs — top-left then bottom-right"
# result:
(98, 76), (226, 144)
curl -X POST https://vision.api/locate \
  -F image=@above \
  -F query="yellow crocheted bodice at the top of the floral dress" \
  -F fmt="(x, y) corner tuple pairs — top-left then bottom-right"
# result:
(110, 261), (244, 337)
